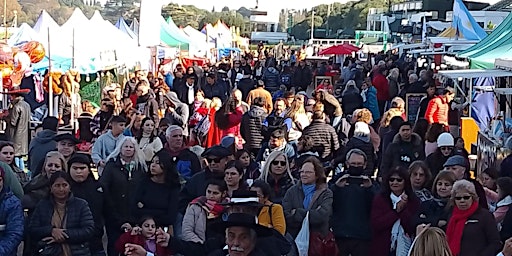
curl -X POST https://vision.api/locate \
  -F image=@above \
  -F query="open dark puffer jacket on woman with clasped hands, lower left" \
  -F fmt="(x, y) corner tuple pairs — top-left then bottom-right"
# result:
(29, 195), (94, 256)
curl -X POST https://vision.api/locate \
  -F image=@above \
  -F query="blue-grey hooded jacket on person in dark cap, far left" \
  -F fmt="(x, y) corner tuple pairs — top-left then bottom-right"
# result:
(28, 129), (57, 177)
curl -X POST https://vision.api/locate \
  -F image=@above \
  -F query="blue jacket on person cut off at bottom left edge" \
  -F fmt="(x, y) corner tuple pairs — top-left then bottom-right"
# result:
(0, 187), (24, 256)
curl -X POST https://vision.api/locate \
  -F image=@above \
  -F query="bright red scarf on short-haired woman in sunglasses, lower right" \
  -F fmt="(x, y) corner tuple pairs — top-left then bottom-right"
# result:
(446, 201), (478, 256)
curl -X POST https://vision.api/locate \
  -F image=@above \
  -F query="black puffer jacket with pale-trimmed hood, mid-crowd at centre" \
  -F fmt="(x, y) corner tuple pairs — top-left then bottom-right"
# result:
(240, 105), (267, 150)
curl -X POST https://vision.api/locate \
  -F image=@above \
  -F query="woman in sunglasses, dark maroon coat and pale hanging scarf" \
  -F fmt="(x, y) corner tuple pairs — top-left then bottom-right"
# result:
(370, 167), (420, 256)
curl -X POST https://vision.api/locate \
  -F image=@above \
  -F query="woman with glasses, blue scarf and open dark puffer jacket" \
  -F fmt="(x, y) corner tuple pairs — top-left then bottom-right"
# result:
(283, 157), (332, 240)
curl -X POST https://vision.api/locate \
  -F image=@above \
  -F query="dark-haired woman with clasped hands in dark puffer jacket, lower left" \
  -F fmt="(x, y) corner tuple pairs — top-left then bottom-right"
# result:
(29, 171), (94, 256)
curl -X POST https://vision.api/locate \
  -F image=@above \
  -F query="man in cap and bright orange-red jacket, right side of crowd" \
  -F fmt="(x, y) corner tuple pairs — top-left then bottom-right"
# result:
(425, 86), (455, 129)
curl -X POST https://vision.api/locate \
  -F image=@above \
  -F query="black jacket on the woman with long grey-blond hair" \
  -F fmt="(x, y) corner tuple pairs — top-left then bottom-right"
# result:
(100, 158), (145, 227)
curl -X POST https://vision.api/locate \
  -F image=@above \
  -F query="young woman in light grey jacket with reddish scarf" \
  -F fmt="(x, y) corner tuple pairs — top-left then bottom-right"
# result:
(182, 180), (228, 244)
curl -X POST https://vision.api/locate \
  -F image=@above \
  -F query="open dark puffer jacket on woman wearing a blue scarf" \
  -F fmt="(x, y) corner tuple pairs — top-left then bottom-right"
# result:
(283, 183), (333, 238)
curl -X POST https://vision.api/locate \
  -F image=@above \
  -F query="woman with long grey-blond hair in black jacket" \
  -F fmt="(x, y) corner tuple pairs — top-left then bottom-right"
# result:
(100, 137), (147, 255)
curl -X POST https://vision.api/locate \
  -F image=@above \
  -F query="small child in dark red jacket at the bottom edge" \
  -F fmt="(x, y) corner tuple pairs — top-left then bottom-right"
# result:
(116, 217), (172, 255)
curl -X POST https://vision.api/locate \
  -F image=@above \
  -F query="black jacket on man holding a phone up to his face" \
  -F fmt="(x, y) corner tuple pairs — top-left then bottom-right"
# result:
(330, 177), (375, 241)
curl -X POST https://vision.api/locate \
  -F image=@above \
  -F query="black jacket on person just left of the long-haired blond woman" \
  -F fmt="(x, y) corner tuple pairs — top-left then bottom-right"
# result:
(71, 174), (109, 253)
